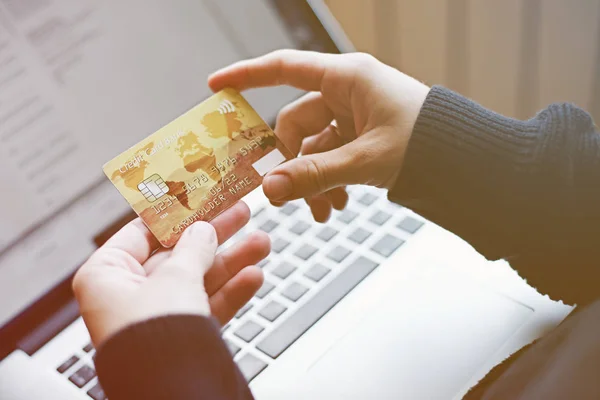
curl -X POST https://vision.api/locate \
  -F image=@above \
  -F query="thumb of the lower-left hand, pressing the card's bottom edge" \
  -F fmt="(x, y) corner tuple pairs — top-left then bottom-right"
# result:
(166, 222), (218, 276)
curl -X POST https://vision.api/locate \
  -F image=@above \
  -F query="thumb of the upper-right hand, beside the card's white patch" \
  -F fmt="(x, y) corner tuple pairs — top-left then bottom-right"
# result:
(262, 141), (365, 201)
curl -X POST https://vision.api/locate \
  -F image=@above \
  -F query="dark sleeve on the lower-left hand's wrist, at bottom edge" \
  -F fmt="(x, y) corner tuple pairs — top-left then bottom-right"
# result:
(95, 315), (253, 400)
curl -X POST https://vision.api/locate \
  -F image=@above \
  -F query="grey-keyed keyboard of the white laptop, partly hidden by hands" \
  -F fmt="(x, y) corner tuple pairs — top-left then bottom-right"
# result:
(57, 186), (424, 394)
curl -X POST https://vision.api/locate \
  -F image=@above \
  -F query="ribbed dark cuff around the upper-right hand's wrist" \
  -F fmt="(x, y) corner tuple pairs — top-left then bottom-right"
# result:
(388, 86), (543, 258)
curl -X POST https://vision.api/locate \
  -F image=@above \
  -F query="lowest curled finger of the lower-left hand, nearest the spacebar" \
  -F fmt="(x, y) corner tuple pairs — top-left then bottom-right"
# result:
(209, 266), (263, 325)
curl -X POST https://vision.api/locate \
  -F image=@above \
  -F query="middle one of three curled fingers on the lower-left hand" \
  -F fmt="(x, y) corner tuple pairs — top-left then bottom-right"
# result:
(204, 231), (271, 296)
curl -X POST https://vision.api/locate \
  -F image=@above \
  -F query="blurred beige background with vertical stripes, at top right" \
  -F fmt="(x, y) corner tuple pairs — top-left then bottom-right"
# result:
(326, 0), (600, 121)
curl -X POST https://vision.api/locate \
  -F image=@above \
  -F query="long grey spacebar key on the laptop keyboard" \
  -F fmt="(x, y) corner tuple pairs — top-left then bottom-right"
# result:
(256, 257), (379, 358)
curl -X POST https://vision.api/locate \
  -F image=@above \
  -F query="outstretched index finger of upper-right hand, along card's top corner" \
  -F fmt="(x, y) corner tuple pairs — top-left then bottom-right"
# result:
(208, 50), (336, 92)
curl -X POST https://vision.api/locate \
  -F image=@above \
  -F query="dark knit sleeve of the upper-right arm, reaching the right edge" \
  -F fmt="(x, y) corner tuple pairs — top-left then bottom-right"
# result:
(389, 86), (600, 304)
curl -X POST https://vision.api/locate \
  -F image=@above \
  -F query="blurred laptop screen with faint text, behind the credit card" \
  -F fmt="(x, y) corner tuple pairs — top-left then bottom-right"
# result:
(0, 0), (335, 326)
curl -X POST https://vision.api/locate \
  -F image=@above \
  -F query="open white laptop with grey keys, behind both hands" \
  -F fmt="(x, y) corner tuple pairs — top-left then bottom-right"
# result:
(0, 0), (571, 400)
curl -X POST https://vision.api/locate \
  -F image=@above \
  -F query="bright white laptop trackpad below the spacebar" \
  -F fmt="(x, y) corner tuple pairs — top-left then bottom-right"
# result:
(292, 273), (533, 399)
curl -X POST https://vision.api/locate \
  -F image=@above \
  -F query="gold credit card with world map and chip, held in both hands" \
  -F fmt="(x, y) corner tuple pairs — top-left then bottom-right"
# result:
(103, 89), (293, 247)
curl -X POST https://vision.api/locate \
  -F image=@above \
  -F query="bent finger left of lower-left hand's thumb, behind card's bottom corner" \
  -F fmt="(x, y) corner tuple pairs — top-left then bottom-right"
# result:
(102, 218), (160, 264)
